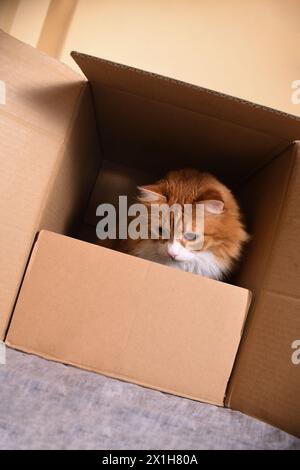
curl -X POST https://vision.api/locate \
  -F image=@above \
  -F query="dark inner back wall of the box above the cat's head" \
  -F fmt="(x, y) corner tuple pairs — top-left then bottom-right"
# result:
(81, 86), (278, 184)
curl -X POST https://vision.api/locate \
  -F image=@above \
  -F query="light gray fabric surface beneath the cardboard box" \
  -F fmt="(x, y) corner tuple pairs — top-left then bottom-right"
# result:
(0, 349), (300, 450)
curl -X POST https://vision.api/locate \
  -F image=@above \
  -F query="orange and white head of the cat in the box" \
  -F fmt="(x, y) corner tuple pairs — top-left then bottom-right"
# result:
(133, 169), (248, 271)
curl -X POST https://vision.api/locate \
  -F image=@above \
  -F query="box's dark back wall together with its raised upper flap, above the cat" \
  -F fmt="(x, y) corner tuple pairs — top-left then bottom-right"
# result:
(72, 52), (300, 184)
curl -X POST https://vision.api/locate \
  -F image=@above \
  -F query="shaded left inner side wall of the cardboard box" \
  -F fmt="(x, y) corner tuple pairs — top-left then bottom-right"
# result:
(38, 88), (102, 234)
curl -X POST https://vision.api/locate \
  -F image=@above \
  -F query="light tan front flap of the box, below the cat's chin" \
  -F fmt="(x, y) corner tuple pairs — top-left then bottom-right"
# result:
(6, 231), (250, 405)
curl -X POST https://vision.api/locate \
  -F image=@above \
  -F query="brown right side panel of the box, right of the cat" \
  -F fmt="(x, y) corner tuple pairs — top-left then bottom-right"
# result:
(227, 143), (300, 436)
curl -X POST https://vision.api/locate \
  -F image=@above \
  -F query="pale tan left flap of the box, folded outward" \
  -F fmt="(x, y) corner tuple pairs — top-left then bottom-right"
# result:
(0, 32), (98, 339)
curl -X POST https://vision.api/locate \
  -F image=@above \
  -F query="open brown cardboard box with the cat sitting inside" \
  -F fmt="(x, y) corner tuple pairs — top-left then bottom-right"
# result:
(0, 33), (300, 435)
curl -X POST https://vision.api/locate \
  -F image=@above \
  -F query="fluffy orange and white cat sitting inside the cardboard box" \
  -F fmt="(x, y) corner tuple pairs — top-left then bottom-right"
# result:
(125, 169), (249, 280)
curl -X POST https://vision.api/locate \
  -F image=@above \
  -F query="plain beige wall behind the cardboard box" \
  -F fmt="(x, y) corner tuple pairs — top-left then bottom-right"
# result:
(0, 0), (300, 116)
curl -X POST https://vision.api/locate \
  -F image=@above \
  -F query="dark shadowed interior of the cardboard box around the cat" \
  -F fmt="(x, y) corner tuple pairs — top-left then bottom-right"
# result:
(67, 84), (292, 290)
